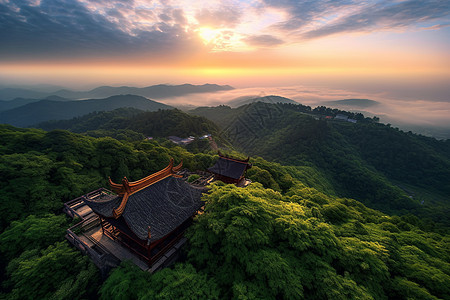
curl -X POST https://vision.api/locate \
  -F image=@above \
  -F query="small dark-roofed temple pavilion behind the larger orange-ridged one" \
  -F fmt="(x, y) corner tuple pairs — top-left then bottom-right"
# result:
(208, 151), (252, 185)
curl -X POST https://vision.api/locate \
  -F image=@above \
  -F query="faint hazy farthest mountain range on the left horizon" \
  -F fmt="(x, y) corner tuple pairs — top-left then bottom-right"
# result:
(0, 84), (234, 100)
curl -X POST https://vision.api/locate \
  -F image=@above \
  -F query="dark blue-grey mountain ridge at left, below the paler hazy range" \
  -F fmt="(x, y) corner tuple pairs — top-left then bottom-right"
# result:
(0, 95), (172, 127)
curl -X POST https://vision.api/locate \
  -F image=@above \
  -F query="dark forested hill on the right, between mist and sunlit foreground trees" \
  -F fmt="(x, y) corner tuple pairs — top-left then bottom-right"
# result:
(191, 103), (450, 226)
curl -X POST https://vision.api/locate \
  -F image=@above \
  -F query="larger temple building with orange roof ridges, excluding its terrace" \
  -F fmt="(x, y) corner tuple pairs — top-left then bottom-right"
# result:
(82, 159), (205, 266)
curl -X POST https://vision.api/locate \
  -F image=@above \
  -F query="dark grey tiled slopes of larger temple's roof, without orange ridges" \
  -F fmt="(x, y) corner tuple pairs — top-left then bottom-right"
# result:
(85, 176), (206, 241)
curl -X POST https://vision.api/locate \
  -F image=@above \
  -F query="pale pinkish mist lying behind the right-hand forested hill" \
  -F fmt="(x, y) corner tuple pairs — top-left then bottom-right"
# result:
(161, 86), (450, 138)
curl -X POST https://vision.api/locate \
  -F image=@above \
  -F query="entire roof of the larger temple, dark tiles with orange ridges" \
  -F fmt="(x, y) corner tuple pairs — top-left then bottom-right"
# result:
(83, 159), (206, 241)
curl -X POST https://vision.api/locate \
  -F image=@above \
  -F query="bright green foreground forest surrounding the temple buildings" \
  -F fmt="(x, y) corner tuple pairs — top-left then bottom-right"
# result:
(0, 125), (450, 299)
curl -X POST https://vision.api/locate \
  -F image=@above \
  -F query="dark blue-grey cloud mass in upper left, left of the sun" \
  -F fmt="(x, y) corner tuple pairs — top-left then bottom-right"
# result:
(0, 0), (201, 60)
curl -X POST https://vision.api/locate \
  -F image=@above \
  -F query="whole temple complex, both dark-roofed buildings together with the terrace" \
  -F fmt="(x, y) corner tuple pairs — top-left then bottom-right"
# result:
(64, 152), (251, 278)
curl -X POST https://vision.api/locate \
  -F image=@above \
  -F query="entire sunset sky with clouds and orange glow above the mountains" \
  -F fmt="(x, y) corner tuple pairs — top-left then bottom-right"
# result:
(0, 0), (450, 120)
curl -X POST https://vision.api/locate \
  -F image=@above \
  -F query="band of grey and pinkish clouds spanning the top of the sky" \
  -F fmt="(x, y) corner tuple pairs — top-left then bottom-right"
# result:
(0, 0), (450, 61)
